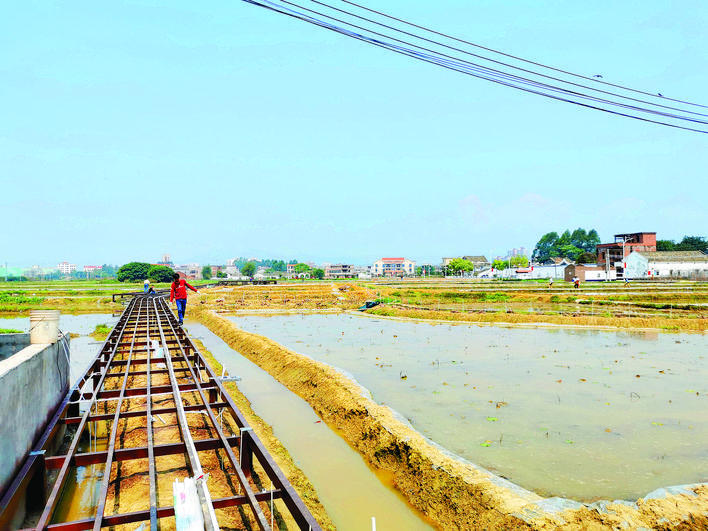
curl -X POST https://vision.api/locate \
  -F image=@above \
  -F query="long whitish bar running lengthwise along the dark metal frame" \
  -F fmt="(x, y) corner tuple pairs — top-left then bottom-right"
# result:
(152, 299), (219, 531)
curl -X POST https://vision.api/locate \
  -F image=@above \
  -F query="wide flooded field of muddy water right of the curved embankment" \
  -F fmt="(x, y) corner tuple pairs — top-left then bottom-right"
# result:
(230, 314), (708, 501)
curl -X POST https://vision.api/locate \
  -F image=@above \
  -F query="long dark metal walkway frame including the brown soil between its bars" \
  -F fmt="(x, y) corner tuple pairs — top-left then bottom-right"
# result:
(0, 295), (320, 530)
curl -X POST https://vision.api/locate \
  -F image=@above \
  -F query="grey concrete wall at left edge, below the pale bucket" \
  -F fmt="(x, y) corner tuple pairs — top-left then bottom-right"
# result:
(0, 342), (69, 492)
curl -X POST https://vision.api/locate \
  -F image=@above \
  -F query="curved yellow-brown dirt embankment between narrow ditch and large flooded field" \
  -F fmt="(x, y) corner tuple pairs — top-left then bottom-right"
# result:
(192, 309), (708, 530)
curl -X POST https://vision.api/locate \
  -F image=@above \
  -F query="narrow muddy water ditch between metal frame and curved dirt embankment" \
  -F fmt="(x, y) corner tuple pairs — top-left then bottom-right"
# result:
(186, 322), (431, 531)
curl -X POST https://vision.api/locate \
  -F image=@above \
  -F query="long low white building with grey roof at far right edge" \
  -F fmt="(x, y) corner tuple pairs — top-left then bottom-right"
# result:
(624, 251), (708, 278)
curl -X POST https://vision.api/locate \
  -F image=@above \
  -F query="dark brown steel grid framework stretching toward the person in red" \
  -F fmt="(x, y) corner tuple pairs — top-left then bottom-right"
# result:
(0, 295), (320, 531)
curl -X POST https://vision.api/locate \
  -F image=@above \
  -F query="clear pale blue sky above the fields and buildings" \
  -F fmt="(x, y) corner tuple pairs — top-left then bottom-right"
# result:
(0, 0), (708, 266)
